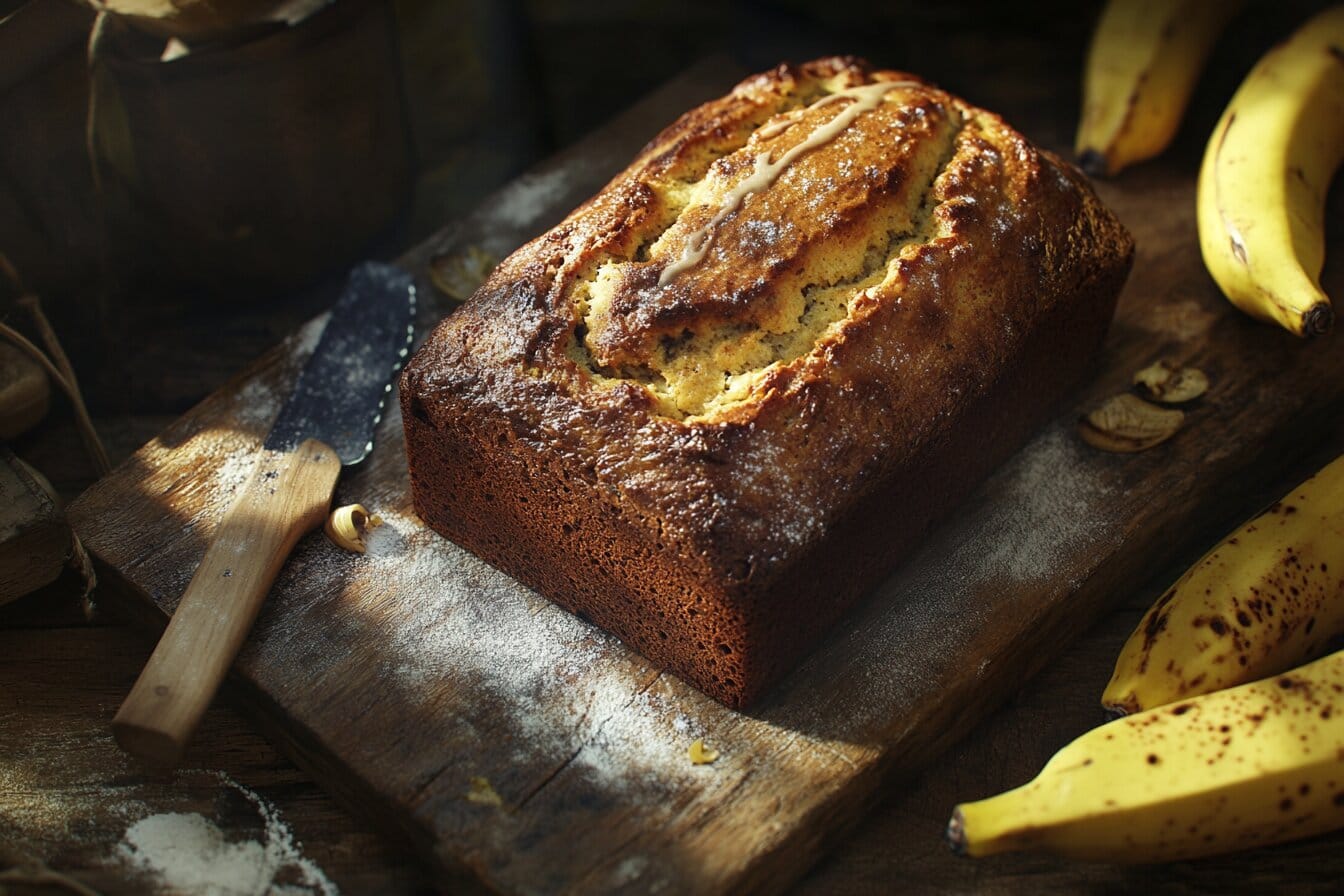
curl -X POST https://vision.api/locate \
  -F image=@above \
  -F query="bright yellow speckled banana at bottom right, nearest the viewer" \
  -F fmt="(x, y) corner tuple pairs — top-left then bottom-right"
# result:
(948, 652), (1344, 862)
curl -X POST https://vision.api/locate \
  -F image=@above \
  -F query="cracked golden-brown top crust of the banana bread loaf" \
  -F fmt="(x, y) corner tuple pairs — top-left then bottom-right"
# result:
(406, 58), (1132, 566)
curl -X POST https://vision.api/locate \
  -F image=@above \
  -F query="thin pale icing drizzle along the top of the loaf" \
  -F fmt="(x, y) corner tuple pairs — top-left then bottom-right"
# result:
(659, 81), (921, 286)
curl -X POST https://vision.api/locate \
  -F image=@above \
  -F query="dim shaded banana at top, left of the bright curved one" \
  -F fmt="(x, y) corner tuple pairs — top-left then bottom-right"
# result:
(1074, 0), (1242, 176)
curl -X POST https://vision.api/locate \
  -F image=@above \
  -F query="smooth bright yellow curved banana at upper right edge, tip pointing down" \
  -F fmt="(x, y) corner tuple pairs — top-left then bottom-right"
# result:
(1198, 7), (1344, 336)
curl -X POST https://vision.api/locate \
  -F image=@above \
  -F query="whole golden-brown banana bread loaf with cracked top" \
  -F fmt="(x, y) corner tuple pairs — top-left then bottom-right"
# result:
(401, 58), (1133, 707)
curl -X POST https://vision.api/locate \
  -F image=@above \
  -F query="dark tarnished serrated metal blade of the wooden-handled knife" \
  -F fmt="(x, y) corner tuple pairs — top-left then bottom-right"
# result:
(266, 262), (415, 465)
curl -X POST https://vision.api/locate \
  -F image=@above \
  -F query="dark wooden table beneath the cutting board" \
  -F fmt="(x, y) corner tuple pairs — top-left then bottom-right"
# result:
(0, 3), (1344, 893)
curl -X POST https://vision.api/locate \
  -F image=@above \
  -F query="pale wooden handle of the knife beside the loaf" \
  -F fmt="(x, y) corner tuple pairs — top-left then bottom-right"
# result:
(112, 439), (341, 766)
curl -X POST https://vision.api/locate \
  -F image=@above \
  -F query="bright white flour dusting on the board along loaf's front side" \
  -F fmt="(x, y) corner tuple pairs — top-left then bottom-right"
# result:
(356, 512), (715, 780)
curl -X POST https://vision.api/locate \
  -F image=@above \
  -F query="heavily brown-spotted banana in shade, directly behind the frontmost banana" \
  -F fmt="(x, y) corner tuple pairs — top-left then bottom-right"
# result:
(1102, 457), (1344, 712)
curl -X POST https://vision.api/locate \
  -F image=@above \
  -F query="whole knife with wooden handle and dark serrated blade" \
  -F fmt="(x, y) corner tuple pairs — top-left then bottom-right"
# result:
(112, 263), (415, 764)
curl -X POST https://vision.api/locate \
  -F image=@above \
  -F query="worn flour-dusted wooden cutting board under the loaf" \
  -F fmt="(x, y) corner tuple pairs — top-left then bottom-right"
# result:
(69, 59), (1344, 893)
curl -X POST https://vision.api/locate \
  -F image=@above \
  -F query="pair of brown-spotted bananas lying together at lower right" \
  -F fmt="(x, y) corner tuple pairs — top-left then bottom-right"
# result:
(948, 457), (1344, 862)
